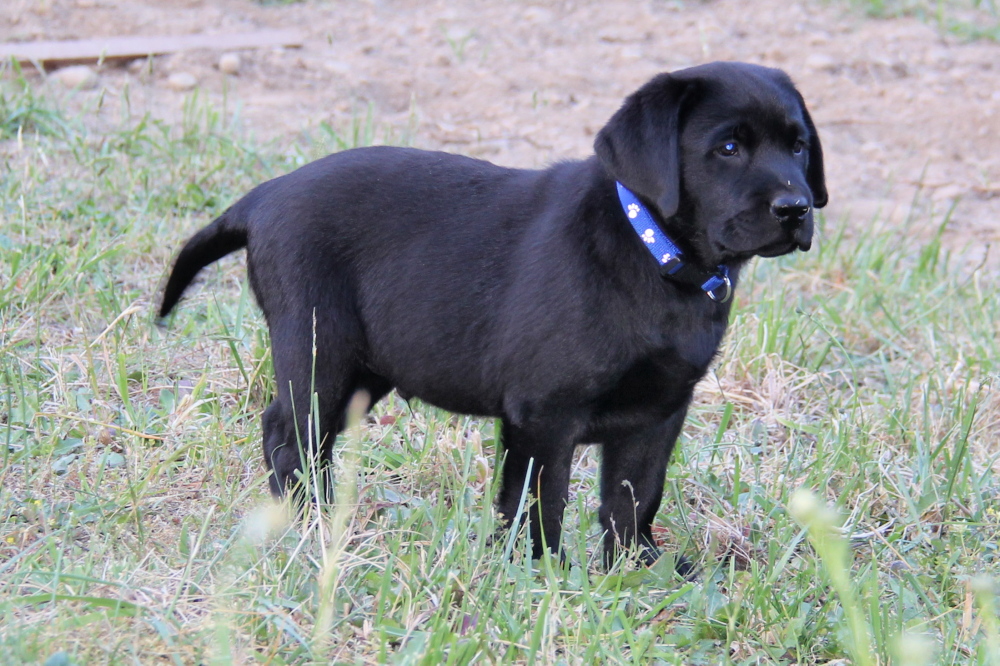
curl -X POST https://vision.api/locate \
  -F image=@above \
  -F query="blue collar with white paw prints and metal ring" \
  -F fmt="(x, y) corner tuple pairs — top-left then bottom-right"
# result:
(615, 181), (733, 303)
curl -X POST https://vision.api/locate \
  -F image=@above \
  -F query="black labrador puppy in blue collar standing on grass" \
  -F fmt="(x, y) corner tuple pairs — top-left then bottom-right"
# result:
(160, 63), (827, 563)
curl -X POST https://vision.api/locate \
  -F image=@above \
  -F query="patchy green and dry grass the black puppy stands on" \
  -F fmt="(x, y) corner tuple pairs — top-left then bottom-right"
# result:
(0, 59), (1000, 664)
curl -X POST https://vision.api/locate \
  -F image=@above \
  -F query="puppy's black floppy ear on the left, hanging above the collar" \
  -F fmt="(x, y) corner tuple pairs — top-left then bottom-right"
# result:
(594, 74), (688, 219)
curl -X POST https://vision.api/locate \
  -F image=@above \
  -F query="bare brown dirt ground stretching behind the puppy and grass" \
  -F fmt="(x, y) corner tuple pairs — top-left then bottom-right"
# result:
(0, 0), (1000, 266)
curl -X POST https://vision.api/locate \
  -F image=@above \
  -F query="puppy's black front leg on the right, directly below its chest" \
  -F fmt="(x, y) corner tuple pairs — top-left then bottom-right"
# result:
(600, 405), (687, 567)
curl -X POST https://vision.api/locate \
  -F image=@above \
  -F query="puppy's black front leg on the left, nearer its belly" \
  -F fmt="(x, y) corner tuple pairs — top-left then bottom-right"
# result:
(497, 419), (575, 559)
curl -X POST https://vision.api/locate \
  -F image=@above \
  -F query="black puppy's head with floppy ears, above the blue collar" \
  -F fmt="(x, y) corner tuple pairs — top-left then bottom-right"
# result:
(594, 63), (827, 266)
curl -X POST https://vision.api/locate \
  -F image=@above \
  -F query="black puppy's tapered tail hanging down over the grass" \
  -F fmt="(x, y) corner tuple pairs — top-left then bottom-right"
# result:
(160, 208), (247, 318)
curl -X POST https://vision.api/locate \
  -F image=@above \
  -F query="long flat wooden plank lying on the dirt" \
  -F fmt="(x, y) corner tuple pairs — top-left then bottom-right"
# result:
(0, 30), (303, 65)
